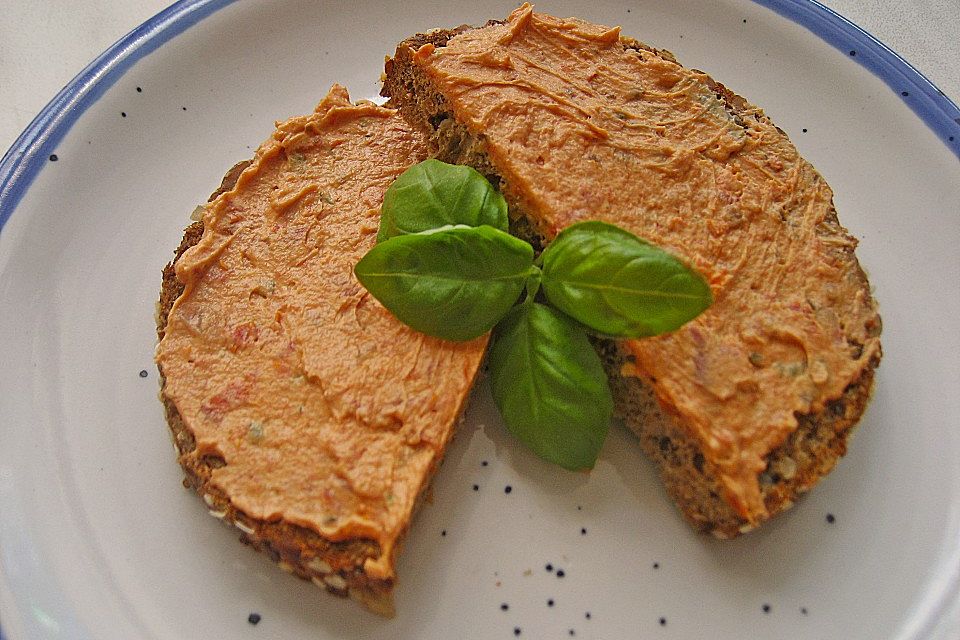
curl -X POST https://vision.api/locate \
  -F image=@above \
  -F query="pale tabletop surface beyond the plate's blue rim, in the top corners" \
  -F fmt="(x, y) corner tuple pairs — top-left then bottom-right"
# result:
(0, 0), (960, 151)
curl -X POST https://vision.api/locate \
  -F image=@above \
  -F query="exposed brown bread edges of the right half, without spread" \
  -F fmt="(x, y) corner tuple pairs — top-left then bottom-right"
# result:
(382, 22), (880, 539)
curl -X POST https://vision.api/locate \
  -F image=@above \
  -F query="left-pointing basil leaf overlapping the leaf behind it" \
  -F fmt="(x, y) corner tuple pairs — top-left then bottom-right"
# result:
(353, 226), (534, 341)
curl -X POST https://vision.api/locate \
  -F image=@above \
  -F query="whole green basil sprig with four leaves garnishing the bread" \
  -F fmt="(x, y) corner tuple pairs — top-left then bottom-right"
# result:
(354, 160), (712, 469)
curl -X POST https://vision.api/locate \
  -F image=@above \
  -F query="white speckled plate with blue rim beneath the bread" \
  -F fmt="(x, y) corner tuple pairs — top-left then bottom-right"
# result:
(0, 0), (960, 640)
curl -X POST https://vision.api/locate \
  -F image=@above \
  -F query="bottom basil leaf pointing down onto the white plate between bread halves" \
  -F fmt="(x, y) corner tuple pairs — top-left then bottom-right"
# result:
(489, 302), (613, 470)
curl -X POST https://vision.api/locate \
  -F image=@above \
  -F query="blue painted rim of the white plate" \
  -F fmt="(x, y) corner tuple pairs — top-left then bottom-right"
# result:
(0, 0), (960, 640)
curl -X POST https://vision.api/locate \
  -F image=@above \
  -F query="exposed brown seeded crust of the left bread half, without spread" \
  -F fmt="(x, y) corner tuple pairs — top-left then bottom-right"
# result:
(157, 161), (394, 616)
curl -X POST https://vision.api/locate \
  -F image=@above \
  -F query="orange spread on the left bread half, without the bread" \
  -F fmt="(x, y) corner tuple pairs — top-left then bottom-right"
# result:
(156, 86), (487, 578)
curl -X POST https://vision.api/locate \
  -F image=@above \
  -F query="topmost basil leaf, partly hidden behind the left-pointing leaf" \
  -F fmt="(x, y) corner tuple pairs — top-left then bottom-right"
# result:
(377, 159), (508, 242)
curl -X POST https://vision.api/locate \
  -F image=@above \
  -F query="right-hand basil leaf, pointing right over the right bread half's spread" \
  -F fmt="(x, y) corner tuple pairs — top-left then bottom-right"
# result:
(542, 221), (713, 338)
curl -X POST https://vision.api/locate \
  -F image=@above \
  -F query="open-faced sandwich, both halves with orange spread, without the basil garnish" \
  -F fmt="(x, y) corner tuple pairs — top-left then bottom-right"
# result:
(157, 5), (881, 614)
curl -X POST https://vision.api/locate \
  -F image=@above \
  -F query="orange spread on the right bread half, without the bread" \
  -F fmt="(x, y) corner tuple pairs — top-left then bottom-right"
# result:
(414, 5), (880, 522)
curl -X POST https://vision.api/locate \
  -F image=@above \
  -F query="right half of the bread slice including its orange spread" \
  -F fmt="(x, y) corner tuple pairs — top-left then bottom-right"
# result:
(382, 5), (881, 538)
